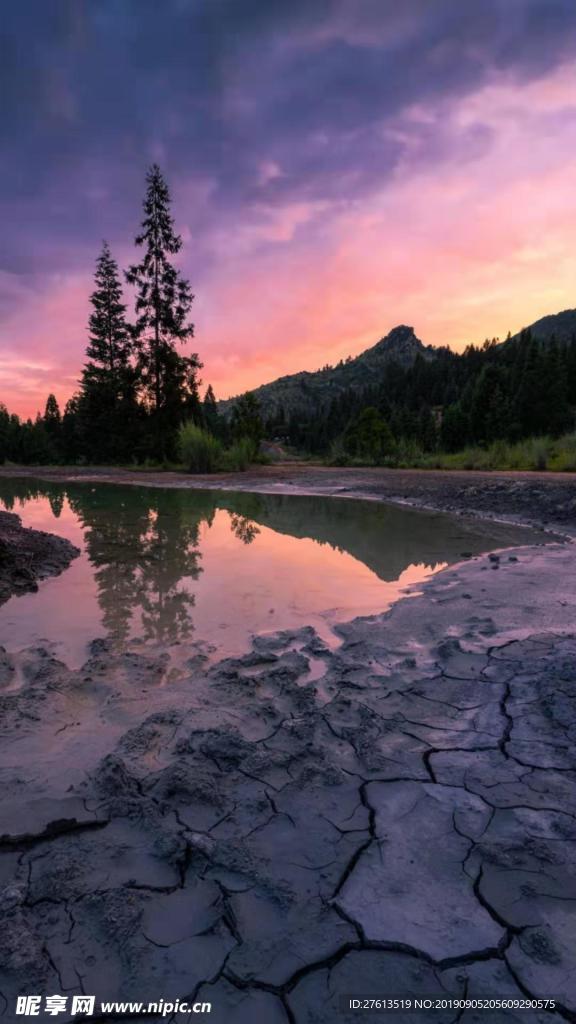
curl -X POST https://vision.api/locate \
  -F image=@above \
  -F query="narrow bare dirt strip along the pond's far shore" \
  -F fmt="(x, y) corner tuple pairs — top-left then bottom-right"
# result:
(0, 463), (576, 534)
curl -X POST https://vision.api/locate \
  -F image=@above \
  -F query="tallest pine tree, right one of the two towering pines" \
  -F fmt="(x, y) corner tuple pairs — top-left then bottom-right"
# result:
(126, 164), (201, 458)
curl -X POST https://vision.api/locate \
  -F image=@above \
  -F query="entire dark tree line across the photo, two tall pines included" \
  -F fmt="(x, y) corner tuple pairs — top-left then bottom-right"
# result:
(0, 165), (576, 471)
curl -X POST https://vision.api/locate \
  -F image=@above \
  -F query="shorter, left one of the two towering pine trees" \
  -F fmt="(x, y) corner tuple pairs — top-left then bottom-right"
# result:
(78, 242), (138, 462)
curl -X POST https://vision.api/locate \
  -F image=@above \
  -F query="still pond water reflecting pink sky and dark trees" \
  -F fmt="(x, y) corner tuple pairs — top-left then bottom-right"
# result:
(0, 478), (532, 668)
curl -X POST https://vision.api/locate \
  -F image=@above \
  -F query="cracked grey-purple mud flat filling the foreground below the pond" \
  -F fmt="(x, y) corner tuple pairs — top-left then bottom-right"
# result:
(0, 544), (576, 1024)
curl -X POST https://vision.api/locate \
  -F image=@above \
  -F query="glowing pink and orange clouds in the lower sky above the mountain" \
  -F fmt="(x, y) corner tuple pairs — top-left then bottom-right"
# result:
(0, 61), (576, 414)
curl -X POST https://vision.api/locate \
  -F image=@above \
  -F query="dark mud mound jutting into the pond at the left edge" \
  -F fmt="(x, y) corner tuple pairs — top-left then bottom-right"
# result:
(0, 512), (80, 604)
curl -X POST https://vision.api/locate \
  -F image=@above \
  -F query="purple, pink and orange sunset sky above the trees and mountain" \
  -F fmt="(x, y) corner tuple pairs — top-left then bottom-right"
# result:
(0, 0), (576, 416)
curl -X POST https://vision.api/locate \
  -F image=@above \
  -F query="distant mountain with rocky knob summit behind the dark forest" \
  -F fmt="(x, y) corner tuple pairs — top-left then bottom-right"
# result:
(218, 325), (437, 418)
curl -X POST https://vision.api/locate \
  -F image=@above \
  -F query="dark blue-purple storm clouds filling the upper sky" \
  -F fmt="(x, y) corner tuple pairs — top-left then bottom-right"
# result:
(0, 0), (576, 273)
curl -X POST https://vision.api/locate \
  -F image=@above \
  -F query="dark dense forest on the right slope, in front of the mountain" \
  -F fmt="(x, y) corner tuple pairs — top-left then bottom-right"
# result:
(265, 330), (576, 462)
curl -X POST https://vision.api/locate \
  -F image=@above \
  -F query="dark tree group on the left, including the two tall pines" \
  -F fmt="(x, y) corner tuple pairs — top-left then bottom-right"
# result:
(0, 164), (260, 464)
